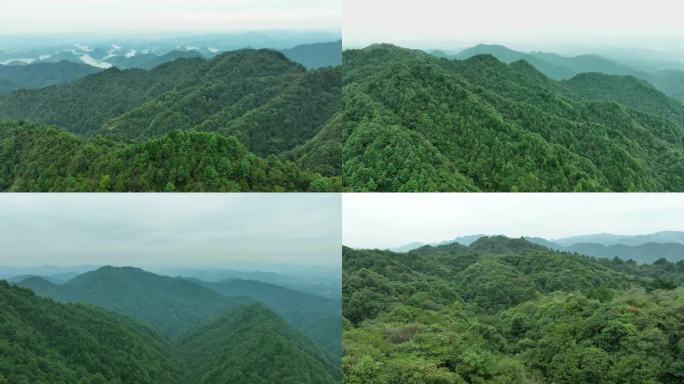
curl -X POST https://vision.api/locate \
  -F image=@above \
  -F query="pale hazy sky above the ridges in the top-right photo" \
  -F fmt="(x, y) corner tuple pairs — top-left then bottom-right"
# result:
(343, 0), (684, 54)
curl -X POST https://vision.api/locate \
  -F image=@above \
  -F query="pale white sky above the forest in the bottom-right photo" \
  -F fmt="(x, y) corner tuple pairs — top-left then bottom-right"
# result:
(342, 193), (684, 248)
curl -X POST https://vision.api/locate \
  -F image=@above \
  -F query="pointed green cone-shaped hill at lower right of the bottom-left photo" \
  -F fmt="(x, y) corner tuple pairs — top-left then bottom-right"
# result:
(181, 304), (340, 384)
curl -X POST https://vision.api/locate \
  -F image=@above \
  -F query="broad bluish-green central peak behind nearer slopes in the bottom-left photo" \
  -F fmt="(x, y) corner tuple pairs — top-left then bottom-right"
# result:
(18, 267), (250, 337)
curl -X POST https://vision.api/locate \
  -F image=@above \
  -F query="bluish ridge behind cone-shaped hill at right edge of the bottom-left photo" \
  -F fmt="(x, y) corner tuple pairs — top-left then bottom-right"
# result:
(199, 279), (342, 362)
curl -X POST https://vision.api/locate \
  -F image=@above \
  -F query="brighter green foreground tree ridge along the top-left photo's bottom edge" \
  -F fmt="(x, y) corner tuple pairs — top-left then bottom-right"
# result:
(0, 122), (341, 192)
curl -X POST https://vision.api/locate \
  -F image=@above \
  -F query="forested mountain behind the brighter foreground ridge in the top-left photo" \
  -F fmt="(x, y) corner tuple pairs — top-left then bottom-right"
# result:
(0, 50), (341, 155)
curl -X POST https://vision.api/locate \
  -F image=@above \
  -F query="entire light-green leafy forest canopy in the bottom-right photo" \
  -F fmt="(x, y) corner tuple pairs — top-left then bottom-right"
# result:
(342, 237), (684, 384)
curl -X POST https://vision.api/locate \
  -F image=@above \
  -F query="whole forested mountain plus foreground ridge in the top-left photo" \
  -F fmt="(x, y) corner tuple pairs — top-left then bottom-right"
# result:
(0, 48), (342, 192)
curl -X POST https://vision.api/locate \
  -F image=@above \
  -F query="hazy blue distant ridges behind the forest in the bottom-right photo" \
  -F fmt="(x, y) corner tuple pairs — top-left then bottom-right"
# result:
(391, 231), (684, 264)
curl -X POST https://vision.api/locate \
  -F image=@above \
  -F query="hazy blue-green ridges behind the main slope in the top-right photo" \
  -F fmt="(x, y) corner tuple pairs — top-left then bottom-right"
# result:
(433, 44), (684, 101)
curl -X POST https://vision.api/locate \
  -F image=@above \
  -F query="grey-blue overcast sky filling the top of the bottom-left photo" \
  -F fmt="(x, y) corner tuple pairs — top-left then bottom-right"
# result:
(0, 193), (341, 268)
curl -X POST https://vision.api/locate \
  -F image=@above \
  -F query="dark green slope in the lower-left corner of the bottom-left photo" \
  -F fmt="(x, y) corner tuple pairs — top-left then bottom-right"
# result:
(0, 281), (190, 384)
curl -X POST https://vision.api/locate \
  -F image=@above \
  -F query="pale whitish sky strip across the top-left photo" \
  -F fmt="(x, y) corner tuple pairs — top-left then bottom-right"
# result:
(0, 0), (342, 34)
